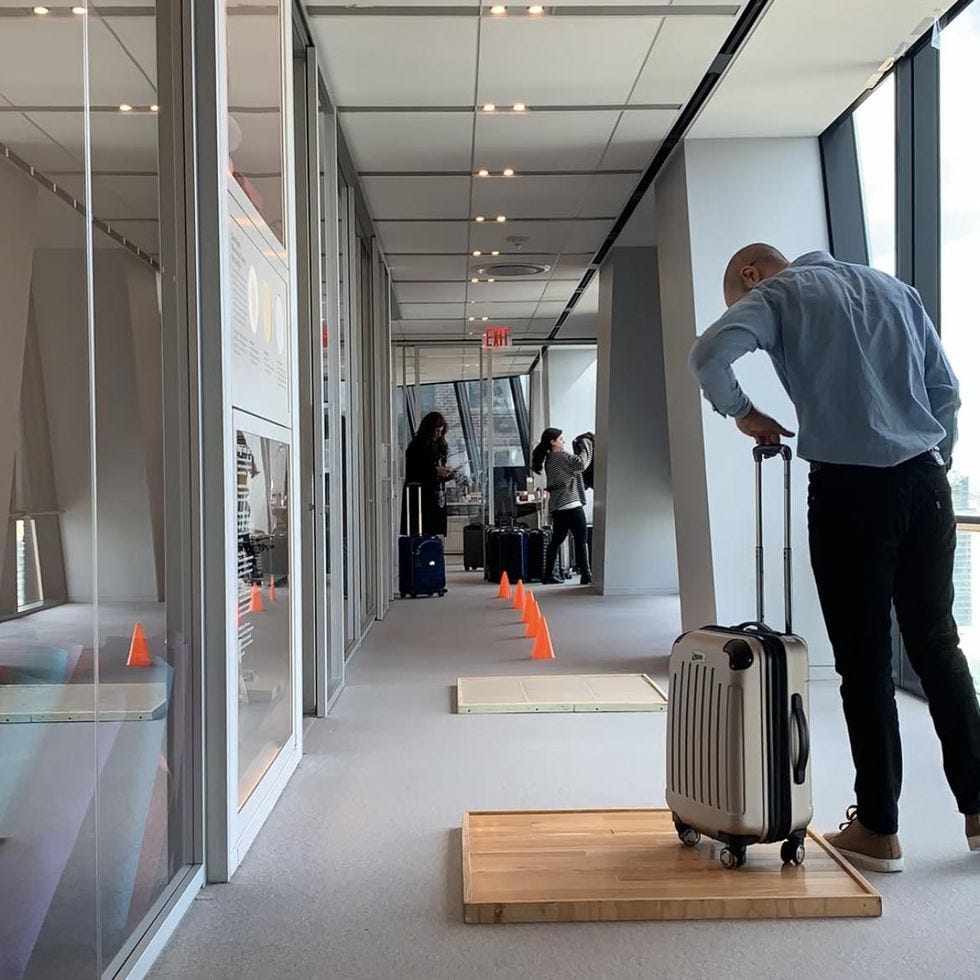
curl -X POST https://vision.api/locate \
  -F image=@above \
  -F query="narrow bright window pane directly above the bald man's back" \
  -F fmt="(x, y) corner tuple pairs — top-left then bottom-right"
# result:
(854, 75), (896, 275)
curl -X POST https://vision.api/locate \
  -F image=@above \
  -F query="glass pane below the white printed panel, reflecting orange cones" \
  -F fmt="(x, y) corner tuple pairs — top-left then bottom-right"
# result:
(236, 429), (293, 808)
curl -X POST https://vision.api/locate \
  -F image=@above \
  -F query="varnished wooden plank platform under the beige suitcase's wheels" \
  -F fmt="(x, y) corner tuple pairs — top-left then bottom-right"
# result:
(463, 810), (881, 923)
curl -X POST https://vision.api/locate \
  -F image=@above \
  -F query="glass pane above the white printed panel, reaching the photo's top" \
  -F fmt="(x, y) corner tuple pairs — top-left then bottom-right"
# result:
(225, 0), (286, 244)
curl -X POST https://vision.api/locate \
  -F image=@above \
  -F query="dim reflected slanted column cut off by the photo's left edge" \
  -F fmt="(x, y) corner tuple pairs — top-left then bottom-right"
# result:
(0, 164), (37, 602)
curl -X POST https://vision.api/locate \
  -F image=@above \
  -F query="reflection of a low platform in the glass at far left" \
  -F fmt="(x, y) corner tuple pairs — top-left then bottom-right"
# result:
(0, 681), (167, 724)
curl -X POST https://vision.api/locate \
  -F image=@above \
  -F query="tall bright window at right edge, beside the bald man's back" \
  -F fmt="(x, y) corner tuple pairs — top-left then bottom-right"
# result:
(939, 3), (980, 687)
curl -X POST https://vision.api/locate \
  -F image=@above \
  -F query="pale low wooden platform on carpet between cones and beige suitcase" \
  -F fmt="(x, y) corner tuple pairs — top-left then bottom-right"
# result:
(456, 674), (667, 714)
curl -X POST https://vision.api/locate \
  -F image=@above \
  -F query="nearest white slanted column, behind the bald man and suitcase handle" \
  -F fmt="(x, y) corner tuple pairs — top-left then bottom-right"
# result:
(655, 138), (832, 665)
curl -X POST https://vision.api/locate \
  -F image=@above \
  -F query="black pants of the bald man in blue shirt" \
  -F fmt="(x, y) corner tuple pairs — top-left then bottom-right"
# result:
(809, 454), (980, 834)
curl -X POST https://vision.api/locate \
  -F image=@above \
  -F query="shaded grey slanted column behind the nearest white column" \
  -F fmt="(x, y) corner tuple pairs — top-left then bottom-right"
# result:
(593, 248), (677, 595)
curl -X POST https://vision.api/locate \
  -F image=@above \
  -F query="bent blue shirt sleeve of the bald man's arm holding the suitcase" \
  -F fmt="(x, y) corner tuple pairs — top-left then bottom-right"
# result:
(689, 287), (779, 419)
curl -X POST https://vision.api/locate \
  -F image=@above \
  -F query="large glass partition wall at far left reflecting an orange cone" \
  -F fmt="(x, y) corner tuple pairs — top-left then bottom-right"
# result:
(0, 2), (201, 980)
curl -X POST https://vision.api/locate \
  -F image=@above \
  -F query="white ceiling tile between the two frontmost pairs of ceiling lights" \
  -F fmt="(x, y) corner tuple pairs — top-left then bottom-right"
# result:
(479, 17), (660, 106)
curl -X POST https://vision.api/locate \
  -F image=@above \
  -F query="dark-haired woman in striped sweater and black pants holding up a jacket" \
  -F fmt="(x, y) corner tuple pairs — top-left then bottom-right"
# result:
(531, 429), (595, 585)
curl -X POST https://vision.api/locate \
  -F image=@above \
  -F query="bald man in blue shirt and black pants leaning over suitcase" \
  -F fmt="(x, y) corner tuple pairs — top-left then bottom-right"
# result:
(691, 244), (980, 871)
